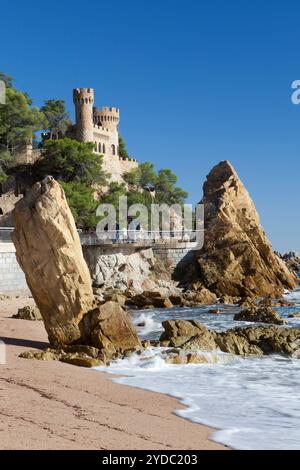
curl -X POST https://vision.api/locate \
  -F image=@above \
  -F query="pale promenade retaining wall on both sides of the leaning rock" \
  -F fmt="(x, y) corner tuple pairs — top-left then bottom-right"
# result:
(0, 238), (195, 294)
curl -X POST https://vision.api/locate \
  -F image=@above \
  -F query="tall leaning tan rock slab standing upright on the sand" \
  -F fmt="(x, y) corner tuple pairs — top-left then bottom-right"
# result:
(12, 177), (94, 345)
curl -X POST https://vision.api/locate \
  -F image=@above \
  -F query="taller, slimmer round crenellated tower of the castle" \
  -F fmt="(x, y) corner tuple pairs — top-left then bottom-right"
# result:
(73, 88), (94, 142)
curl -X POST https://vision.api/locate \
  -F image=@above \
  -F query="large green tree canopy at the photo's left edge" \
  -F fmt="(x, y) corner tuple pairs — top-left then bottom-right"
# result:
(0, 73), (45, 180)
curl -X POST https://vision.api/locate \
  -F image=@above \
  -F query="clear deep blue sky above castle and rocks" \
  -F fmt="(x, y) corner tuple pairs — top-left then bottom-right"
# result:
(0, 0), (300, 251)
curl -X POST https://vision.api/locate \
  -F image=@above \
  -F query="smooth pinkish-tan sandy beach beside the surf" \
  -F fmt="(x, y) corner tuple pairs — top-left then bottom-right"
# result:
(0, 297), (225, 450)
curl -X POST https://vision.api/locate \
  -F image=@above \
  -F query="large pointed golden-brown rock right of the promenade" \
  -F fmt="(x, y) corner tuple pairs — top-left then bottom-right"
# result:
(190, 161), (296, 298)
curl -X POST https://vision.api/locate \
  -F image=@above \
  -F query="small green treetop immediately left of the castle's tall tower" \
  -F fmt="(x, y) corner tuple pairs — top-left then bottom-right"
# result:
(41, 100), (71, 138)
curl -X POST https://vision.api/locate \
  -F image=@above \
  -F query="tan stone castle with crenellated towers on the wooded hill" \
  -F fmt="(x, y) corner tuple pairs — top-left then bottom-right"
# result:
(67, 88), (138, 182)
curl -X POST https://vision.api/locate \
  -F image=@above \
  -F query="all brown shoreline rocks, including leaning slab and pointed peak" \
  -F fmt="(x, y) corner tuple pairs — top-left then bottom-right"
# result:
(7, 165), (299, 367)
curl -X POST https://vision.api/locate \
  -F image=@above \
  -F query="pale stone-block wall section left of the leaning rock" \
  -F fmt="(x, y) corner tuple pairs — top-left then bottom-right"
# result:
(0, 243), (28, 294)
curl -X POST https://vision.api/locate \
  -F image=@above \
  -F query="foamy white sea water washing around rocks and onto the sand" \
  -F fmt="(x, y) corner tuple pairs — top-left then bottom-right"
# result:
(98, 290), (300, 449)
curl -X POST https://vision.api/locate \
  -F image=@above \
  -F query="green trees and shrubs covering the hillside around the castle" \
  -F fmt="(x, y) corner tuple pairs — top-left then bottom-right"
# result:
(0, 73), (188, 230)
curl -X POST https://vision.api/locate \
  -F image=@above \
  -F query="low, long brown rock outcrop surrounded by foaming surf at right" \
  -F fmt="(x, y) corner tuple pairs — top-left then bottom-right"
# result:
(160, 320), (300, 358)
